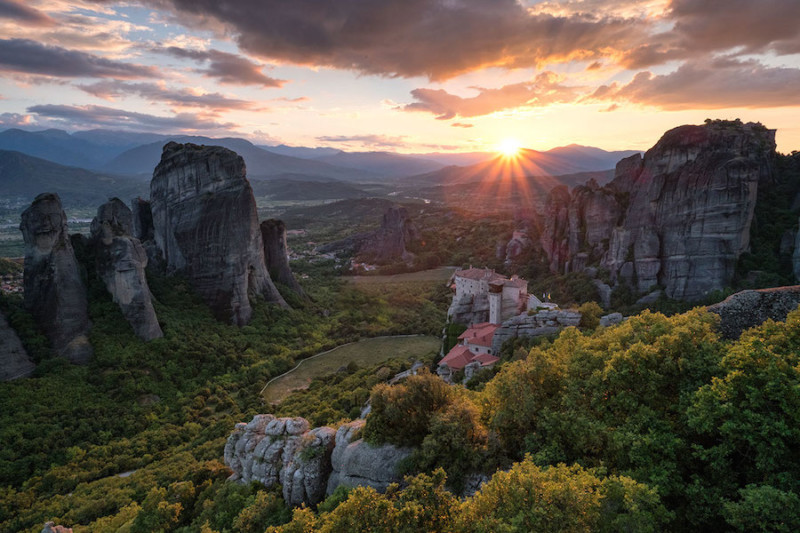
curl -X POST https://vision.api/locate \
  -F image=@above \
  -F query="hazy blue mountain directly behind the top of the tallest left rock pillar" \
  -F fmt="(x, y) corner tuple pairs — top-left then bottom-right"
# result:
(102, 136), (376, 181)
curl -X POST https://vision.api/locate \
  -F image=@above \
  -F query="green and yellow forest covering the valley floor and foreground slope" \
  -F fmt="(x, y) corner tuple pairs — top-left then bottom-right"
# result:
(0, 251), (800, 533)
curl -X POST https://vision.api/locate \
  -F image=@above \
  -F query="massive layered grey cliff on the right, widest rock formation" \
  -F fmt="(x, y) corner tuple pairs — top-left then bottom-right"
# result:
(541, 121), (775, 300)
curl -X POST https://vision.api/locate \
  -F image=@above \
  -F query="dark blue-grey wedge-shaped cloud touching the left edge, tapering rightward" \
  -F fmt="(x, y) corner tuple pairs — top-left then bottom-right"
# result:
(0, 39), (157, 79)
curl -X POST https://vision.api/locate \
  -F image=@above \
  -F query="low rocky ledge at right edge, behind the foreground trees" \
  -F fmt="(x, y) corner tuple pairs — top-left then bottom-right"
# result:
(708, 285), (800, 339)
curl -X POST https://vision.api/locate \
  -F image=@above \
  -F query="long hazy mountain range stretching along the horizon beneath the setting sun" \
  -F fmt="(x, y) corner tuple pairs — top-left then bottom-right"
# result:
(0, 125), (636, 205)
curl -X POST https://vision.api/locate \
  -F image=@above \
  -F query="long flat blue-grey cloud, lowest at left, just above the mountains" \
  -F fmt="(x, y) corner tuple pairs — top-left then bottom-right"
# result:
(27, 105), (235, 131)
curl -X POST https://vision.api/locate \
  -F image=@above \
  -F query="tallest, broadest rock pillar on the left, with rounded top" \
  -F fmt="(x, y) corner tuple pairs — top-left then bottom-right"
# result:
(150, 142), (286, 325)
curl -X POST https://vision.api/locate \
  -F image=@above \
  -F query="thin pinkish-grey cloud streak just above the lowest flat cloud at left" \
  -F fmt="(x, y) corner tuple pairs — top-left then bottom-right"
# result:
(78, 80), (256, 111)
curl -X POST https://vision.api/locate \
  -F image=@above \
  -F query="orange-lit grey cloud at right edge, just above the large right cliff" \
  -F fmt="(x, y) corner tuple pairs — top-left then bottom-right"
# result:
(589, 59), (800, 110)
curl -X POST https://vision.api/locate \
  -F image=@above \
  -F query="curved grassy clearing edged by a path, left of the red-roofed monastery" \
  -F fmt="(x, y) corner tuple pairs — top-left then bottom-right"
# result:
(263, 336), (440, 405)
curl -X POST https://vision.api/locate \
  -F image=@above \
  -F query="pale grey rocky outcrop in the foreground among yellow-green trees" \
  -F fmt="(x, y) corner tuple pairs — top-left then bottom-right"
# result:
(225, 415), (410, 506)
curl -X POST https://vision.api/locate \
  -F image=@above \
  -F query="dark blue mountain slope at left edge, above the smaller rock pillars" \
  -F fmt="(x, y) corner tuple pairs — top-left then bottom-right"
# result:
(0, 150), (150, 206)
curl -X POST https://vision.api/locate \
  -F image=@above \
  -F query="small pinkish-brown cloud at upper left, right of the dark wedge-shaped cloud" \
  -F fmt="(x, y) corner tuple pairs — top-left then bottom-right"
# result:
(157, 46), (286, 87)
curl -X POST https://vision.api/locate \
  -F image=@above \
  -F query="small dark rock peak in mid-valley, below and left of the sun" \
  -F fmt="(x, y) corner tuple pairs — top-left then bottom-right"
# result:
(357, 207), (419, 264)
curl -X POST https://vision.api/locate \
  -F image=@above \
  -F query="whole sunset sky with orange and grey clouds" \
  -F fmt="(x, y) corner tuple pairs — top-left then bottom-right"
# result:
(0, 0), (800, 153)
